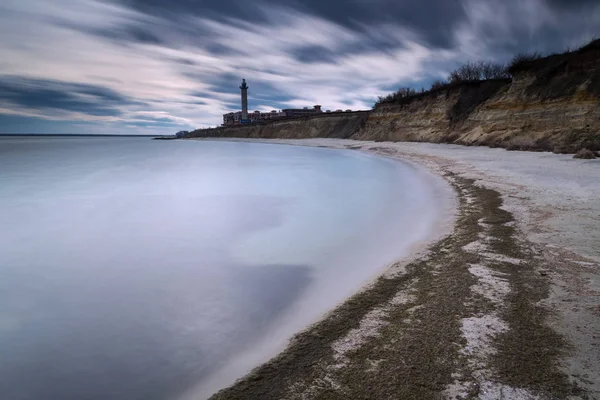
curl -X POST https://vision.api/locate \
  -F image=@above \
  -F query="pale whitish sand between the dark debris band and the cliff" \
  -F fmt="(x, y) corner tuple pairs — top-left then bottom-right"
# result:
(254, 139), (600, 398)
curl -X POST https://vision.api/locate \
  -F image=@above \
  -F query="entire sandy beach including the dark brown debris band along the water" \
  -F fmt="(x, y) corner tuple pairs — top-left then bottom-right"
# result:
(195, 139), (600, 399)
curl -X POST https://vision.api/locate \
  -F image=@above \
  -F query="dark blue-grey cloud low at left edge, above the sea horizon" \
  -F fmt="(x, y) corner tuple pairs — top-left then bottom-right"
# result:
(0, 76), (140, 116)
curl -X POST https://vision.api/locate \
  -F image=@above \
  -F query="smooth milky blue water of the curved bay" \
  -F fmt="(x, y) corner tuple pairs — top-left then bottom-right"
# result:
(0, 138), (438, 400)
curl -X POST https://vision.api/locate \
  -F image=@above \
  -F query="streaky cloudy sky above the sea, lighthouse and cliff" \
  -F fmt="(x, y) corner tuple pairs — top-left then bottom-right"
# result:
(0, 0), (600, 134)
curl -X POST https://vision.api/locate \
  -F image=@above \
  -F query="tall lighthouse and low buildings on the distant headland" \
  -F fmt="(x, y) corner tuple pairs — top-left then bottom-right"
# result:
(223, 79), (352, 126)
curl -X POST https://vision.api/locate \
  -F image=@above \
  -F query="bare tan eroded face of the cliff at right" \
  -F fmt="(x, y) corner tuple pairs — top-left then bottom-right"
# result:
(351, 73), (600, 153)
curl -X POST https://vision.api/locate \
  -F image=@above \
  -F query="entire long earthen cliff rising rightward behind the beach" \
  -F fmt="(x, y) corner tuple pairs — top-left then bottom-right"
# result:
(191, 40), (600, 152)
